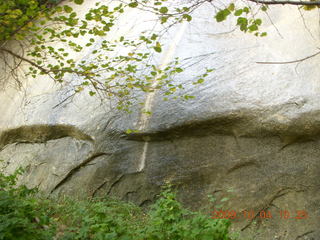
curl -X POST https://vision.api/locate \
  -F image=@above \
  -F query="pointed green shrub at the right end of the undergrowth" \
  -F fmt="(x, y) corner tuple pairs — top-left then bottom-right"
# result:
(142, 187), (230, 240)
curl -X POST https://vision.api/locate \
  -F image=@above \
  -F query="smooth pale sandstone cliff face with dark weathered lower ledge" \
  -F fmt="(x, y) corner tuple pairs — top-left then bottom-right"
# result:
(0, 0), (320, 240)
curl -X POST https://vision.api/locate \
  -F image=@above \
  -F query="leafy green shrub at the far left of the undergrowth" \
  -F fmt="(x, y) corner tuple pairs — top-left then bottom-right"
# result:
(0, 169), (54, 240)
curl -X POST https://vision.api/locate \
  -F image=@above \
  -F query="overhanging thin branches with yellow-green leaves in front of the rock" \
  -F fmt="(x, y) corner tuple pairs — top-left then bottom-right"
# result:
(0, 0), (319, 109)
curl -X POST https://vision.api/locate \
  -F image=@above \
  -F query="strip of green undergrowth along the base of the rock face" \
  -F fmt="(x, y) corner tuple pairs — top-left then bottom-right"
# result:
(0, 170), (235, 240)
